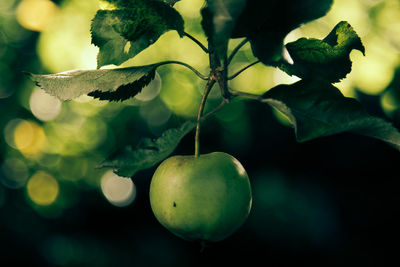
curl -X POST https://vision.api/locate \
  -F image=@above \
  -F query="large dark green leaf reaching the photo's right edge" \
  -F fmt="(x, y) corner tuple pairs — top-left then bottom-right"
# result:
(262, 80), (400, 149)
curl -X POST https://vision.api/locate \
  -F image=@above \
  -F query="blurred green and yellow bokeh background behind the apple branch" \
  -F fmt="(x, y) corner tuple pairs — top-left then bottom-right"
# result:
(0, 0), (400, 266)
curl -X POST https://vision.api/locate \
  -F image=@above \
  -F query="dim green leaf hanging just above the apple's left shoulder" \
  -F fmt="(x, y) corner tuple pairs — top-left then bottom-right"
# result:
(100, 121), (196, 177)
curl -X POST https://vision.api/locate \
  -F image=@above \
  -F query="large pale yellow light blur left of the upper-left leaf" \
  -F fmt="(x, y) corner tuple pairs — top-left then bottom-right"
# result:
(37, 0), (98, 73)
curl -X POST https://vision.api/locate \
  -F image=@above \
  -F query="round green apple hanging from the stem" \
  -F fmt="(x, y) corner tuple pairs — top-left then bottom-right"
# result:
(150, 152), (252, 242)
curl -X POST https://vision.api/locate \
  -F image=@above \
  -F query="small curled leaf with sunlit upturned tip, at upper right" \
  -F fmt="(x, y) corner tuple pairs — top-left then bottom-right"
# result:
(282, 21), (365, 82)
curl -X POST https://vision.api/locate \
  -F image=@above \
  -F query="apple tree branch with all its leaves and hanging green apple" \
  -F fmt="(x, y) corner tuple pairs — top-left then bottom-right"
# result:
(29, 0), (400, 244)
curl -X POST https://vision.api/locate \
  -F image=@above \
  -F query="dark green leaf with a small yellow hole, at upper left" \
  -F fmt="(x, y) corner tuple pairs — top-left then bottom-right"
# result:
(91, 0), (184, 67)
